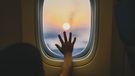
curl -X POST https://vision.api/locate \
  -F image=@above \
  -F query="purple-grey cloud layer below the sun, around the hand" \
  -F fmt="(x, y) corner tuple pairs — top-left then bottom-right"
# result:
(43, 25), (90, 57)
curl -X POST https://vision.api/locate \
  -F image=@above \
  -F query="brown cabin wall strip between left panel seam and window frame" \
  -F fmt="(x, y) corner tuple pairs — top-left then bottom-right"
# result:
(21, 0), (36, 45)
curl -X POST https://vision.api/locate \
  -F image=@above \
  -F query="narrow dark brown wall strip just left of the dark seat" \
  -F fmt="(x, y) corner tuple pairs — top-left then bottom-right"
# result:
(111, 14), (124, 76)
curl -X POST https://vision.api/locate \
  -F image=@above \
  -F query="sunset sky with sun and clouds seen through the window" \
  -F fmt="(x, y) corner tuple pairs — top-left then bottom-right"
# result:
(43, 0), (91, 55)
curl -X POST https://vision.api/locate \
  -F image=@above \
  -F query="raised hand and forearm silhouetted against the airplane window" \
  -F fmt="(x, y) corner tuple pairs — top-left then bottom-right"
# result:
(55, 32), (76, 76)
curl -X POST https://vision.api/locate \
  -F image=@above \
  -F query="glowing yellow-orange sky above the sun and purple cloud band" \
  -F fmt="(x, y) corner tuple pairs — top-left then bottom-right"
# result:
(43, 0), (91, 28)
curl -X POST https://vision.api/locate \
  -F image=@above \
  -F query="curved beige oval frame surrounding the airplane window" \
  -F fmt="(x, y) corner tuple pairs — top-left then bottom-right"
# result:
(35, 0), (99, 67)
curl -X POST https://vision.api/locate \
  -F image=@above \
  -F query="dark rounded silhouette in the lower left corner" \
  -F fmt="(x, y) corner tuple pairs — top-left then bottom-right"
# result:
(0, 43), (44, 76)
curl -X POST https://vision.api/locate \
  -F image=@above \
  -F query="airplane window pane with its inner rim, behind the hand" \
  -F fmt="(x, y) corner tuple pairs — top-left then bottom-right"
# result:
(39, 0), (95, 59)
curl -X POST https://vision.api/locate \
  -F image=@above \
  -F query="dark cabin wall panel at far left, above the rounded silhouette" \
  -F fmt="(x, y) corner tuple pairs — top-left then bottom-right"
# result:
(0, 0), (22, 47)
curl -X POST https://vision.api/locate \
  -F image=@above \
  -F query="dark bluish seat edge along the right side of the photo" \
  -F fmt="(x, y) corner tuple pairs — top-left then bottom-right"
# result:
(115, 0), (135, 72)
